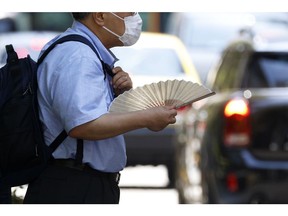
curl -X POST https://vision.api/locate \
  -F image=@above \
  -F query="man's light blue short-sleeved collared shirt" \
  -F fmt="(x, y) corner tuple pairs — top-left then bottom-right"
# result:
(37, 21), (126, 172)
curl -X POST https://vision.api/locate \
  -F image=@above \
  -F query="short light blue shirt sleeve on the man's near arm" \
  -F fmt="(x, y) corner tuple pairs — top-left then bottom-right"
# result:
(50, 45), (109, 131)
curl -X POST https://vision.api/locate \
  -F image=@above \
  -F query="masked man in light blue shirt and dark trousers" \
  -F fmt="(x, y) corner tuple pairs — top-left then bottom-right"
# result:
(24, 12), (177, 204)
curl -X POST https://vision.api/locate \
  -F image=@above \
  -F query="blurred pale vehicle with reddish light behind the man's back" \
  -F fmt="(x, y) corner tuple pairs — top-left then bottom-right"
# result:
(0, 31), (59, 67)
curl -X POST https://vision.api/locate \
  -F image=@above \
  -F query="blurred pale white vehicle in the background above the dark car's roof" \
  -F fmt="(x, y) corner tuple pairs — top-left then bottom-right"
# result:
(166, 12), (288, 84)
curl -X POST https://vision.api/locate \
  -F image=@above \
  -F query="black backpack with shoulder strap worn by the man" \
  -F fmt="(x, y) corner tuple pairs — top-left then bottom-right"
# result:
(0, 34), (113, 188)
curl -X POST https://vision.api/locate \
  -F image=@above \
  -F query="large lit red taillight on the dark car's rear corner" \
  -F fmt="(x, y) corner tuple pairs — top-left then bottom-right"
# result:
(224, 99), (251, 147)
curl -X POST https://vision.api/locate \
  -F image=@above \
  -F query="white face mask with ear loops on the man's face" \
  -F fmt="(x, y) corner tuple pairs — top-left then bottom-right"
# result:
(103, 12), (142, 46)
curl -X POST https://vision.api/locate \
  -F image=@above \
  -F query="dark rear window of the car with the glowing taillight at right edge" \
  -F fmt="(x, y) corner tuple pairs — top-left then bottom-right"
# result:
(244, 53), (288, 88)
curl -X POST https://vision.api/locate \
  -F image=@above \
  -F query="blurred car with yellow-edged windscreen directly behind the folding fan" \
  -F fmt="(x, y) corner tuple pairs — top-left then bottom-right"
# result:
(111, 32), (200, 186)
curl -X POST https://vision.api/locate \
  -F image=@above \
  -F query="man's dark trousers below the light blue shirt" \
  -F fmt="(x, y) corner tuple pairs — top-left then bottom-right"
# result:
(24, 164), (120, 204)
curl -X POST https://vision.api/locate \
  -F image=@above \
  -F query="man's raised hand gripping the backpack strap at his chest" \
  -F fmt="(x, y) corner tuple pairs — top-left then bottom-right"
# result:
(112, 67), (133, 96)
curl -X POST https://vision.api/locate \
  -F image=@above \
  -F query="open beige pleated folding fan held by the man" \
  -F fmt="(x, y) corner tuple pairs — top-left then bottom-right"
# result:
(109, 80), (215, 113)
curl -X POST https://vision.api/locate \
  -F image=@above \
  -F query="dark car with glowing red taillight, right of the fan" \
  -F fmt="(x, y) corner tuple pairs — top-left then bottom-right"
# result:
(176, 35), (288, 203)
